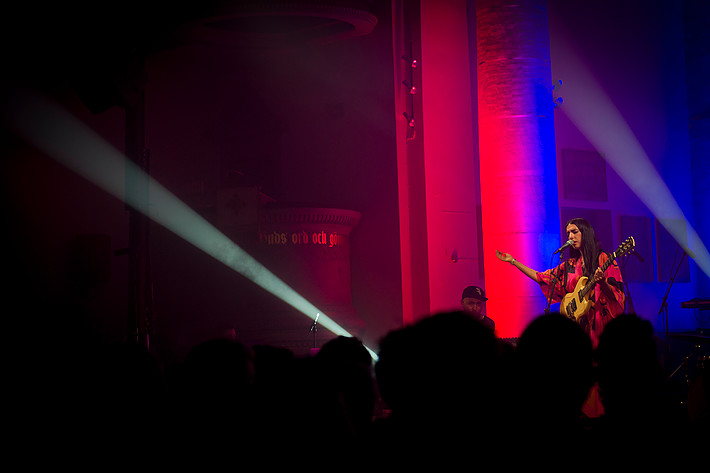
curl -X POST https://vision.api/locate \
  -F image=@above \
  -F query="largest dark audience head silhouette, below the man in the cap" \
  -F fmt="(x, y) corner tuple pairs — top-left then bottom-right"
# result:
(373, 312), (504, 466)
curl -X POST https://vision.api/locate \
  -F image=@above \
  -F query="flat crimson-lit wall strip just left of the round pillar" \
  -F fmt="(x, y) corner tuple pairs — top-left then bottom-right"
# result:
(419, 0), (482, 313)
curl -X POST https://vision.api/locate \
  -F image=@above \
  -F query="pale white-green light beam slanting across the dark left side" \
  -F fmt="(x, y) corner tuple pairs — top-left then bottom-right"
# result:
(3, 90), (377, 360)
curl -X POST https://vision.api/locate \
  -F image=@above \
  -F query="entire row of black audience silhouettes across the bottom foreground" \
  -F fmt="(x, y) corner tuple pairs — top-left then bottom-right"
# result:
(18, 298), (707, 464)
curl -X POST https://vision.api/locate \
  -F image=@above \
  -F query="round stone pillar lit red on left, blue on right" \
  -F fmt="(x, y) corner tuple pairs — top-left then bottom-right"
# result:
(475, 0), (561, 337)
